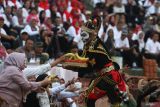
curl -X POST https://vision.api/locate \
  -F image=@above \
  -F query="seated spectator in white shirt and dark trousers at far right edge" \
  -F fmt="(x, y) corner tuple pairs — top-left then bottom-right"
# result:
(145, 32), (160, 65)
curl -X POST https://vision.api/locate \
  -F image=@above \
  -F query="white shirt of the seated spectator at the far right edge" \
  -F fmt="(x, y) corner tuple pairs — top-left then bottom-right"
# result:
(145, 39), (160, 54)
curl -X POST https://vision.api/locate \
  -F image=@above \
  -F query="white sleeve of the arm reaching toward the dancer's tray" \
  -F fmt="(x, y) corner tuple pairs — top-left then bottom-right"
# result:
(23, 63), (51, 77)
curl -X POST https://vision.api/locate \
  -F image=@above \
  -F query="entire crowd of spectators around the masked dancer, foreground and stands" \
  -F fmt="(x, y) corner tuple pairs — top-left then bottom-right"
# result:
(0, 0), (160, 107)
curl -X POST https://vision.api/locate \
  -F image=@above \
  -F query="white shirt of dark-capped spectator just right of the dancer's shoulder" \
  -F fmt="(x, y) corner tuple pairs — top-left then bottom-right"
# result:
(115, 38), (130, 48)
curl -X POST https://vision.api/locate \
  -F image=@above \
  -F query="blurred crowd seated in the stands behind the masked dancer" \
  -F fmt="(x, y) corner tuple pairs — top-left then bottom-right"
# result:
(0, 0), (160, 107)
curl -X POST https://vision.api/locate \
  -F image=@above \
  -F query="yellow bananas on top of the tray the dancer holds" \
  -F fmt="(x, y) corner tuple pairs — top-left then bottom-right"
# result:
(65, 53), (88, 61)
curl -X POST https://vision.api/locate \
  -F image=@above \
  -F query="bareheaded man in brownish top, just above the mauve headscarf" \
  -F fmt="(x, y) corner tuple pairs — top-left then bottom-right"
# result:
(16, 39), (35, 61)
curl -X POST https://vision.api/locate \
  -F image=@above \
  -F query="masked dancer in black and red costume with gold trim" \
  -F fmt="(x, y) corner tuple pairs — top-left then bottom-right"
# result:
(63, 17), (127, 107)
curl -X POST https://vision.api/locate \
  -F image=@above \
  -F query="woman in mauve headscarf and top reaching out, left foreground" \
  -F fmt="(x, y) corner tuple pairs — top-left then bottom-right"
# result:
(0, 52), (51, 107)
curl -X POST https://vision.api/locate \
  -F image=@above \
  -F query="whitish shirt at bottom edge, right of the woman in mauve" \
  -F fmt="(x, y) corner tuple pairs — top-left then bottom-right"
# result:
(37, 91), (50, 107)
